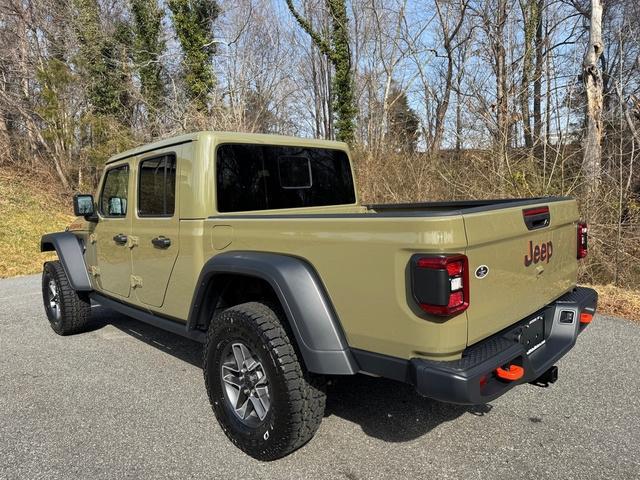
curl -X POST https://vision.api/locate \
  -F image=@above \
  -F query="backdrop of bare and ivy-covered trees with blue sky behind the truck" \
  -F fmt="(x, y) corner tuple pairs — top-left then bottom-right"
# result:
(0, 0), (640, 285)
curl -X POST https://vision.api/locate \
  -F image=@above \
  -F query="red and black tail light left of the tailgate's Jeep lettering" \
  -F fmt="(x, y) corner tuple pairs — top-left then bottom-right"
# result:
(411, 255), (469, 317)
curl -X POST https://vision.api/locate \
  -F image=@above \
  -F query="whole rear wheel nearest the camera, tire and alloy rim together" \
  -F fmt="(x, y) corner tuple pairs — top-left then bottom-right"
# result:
(204, 302), (325, 460)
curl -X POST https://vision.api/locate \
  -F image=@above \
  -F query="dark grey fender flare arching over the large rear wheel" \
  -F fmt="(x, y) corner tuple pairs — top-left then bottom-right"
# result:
(187, 251), (359, 375)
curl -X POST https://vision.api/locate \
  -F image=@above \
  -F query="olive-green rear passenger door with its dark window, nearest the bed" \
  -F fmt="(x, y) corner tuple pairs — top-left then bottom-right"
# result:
(131, 152), (179, 307)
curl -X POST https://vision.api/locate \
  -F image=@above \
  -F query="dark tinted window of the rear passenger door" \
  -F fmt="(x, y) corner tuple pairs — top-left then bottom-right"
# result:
(138, 154), (176, 217)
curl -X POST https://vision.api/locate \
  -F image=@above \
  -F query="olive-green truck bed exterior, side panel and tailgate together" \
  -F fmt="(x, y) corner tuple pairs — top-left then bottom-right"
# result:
(200, 197), (578, 358)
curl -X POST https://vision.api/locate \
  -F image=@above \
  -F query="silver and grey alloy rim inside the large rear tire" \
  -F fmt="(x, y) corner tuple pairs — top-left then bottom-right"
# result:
(220, 342), (271, 427)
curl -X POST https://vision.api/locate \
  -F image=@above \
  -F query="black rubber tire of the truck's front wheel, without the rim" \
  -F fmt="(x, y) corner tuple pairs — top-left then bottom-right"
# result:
(42, 260), (91, 335)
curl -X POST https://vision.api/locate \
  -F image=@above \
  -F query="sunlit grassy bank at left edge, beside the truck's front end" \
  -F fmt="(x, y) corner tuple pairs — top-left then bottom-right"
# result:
(0, 167), (73, 278)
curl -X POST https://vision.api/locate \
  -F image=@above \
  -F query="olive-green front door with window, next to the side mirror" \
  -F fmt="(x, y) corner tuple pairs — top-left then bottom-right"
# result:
(93, 163), (132, 298)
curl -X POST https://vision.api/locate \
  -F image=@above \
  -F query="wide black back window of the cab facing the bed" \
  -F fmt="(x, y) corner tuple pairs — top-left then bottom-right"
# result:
(216, 144), (356, 212)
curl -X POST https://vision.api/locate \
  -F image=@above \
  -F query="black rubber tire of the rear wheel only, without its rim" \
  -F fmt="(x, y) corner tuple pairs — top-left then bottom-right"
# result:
(203, 302), (326, 461)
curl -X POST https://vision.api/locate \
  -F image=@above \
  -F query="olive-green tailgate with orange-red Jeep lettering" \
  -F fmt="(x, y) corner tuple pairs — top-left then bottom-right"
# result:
(464, 200), (578, 345)
